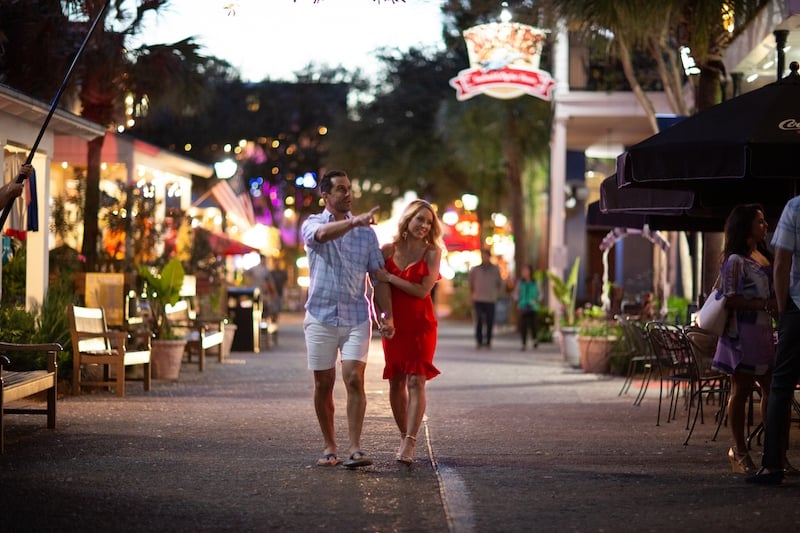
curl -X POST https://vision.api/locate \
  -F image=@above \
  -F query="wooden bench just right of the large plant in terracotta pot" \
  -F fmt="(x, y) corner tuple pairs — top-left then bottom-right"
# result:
(166, 300), (225, 372)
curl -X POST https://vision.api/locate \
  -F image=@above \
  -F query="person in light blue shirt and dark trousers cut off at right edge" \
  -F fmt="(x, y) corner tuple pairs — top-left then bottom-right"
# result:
(747, 196), (800, 485)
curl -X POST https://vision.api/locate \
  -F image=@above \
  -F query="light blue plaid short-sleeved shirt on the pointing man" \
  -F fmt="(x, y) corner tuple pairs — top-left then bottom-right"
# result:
(301, 209), (384, 326)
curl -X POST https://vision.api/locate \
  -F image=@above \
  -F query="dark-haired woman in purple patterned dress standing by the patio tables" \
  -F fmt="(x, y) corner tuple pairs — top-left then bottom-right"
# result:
(712, 204), (775, 474)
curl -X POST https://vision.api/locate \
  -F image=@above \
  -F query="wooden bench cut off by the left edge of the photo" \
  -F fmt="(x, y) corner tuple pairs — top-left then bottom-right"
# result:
(0, 342), (63, 454)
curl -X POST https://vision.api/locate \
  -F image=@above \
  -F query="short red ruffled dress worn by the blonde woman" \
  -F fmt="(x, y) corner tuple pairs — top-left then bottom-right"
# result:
(383, 257), (439, 379)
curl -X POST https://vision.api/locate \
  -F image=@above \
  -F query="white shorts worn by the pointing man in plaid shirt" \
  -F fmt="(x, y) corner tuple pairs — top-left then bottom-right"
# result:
(303, 312), (372, 370)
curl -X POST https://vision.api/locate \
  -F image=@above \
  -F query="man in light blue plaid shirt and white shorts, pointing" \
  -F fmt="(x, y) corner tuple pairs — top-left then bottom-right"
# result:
(301, 170), (394, 467)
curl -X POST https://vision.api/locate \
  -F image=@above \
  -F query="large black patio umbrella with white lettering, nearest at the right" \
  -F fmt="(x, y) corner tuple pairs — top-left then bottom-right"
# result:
(617, 62), (800, 217)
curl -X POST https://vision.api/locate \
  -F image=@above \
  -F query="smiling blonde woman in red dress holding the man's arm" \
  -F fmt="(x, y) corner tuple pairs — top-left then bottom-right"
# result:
(379, 200), (444, 465)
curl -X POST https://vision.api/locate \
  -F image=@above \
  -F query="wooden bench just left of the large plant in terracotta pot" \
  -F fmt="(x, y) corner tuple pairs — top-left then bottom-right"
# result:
(69, 305), (150, 397)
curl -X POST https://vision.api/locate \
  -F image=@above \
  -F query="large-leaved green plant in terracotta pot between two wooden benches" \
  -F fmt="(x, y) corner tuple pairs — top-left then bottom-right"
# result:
(139, 258), (186, 380)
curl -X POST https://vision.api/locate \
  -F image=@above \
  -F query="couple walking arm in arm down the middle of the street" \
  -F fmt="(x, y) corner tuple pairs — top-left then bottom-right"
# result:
(302, 170), (443, 468)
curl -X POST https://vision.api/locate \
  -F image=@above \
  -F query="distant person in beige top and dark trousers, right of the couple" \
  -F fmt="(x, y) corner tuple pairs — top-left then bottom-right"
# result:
(467, 248), (503, 349)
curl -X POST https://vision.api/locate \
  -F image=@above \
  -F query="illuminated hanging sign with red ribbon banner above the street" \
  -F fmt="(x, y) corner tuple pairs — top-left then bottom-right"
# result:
(450, 22), (555, 100)
